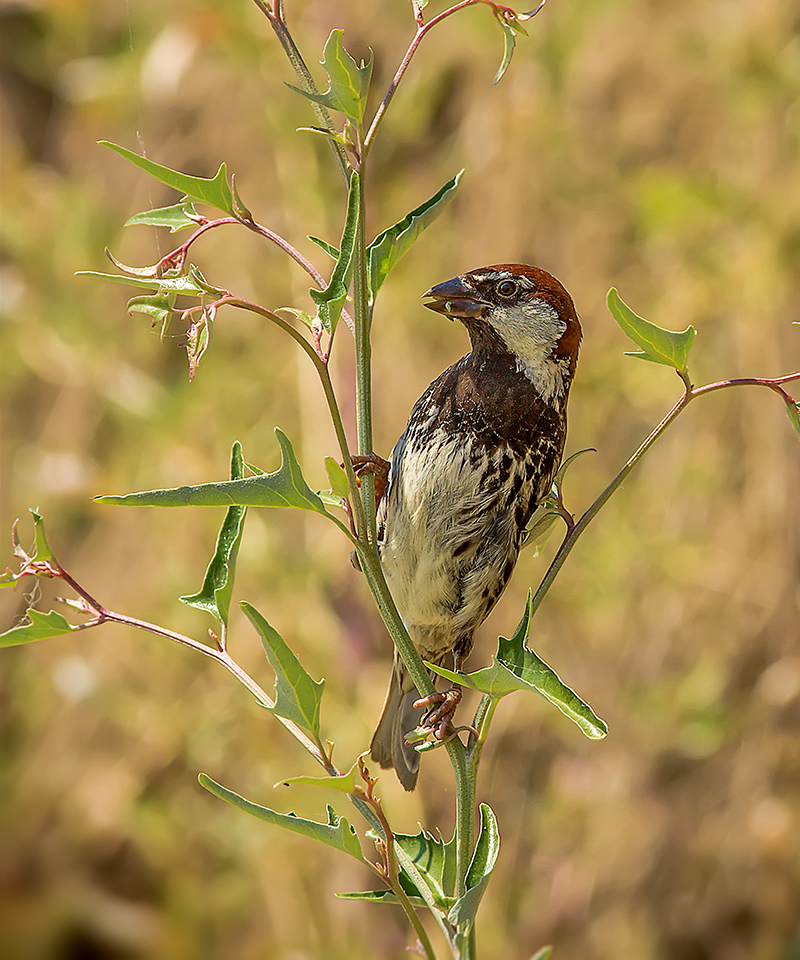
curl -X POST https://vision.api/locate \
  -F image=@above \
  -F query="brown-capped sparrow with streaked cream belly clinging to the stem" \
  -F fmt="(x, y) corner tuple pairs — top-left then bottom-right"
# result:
(354, 263), (581, 790)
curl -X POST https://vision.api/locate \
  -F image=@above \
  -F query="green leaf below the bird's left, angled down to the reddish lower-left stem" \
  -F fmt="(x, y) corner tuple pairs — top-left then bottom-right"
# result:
(239, 601), (325, 743)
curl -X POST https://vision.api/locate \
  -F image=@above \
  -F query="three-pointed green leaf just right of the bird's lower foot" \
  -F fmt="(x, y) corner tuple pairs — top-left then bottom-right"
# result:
(425, 591), (608, 740)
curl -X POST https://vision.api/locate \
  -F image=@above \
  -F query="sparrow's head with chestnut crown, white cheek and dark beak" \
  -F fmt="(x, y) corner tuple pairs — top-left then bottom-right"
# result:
(423, 263), (581, 394)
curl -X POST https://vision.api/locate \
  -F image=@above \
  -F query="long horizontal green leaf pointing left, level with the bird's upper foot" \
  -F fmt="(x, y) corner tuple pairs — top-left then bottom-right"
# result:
(95, 427), (326, 514)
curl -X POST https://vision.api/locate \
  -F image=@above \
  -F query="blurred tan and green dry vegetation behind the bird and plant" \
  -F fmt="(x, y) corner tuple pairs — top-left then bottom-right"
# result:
(0, 0), (800, 960)
